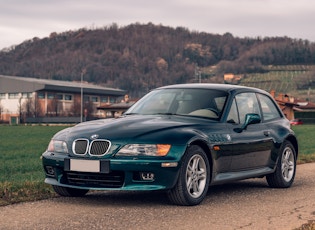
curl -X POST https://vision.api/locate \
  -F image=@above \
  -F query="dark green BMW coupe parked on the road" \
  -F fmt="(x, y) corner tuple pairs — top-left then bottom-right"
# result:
(42, 84), (298, 205)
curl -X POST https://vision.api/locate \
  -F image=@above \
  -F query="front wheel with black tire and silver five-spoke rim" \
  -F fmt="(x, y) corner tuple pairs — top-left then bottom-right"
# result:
(168, 145), (210, 206)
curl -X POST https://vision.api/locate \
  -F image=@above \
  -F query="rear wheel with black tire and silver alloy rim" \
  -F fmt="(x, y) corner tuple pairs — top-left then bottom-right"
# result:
(266, 141), (296, 188)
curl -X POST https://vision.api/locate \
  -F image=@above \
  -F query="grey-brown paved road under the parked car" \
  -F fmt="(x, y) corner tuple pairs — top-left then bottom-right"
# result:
(0, 163), (315, 230)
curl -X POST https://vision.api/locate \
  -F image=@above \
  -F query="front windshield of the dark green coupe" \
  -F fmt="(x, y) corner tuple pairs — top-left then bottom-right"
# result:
(125, 88), (227, 119)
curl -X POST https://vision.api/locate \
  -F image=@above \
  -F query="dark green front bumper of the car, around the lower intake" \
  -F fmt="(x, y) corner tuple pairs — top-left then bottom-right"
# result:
(42, 152), (180, 191)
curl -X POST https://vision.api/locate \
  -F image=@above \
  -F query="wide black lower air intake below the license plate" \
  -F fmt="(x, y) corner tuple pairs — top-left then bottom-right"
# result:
(65, 171), (124, 188)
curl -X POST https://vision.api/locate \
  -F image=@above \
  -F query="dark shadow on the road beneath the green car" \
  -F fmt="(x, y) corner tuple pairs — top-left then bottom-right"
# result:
(55, 179), (270, 207)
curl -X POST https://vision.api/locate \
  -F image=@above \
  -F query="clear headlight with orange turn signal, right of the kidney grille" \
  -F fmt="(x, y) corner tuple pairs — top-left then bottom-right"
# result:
(116, 144), (171, 156)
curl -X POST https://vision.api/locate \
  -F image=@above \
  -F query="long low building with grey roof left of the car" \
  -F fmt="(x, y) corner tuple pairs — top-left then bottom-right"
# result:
(0, 75), (126, 123)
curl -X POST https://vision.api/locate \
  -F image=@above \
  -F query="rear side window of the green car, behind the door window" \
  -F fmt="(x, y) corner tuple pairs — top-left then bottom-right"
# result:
(257, 94), (282, 121)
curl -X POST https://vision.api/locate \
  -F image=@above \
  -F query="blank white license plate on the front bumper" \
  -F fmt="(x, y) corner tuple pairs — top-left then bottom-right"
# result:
(70, 159), (101, 172)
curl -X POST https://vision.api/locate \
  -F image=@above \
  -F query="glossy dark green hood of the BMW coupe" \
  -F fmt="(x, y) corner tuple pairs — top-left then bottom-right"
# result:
(56, 115), (214, 142)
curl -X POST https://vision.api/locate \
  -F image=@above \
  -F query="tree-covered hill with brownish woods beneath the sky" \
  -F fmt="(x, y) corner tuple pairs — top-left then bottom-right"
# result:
(0, 23), (315, 97)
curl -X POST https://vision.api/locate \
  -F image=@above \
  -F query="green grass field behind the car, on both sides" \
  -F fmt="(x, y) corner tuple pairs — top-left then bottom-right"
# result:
(0, 125), (315, 206)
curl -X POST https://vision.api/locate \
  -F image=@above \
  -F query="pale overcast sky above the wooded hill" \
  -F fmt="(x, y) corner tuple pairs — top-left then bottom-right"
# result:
(0, 0), (315, 50)
